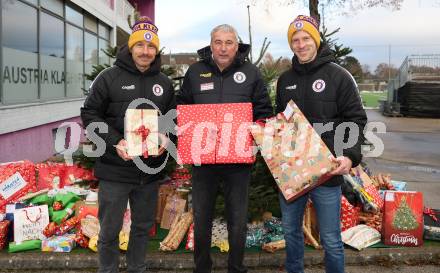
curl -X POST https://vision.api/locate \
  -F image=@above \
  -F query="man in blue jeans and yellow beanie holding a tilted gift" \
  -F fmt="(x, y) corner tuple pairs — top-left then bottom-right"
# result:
(276, 15), (367, 273)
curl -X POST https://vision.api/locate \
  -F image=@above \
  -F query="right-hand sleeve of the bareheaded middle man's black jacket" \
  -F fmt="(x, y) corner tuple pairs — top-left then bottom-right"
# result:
(252, 69), (273, 121)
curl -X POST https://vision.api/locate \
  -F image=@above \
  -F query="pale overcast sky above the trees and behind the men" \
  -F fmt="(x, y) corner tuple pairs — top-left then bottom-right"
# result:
(155, 0), (440, 70)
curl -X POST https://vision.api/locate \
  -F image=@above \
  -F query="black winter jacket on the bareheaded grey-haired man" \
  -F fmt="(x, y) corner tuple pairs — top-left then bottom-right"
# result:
(177, 44), (273, 120)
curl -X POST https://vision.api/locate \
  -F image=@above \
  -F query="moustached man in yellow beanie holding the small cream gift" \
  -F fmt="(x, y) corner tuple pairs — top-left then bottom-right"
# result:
(81, 17), (175, 273)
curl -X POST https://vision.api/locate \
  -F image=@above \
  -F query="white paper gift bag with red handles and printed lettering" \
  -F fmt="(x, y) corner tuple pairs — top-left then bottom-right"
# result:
(14, 205), (49, 243)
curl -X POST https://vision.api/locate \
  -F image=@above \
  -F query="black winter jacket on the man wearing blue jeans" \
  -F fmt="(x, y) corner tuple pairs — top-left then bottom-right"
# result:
(276, 44), (367, 186)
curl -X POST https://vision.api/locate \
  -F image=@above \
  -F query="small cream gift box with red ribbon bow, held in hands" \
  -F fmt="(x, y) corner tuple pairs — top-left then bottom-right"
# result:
(125, 109), (159, 157)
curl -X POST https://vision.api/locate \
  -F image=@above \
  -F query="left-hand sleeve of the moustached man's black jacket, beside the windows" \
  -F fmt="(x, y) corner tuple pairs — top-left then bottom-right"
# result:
(81, 72), (124, 147)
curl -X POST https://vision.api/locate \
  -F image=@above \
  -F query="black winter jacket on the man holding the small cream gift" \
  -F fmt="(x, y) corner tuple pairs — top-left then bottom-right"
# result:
(81, 46), (176, 183)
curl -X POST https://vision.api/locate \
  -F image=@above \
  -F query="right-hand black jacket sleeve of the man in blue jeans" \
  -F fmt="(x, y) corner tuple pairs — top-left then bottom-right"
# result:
(337, 71), (367, 167)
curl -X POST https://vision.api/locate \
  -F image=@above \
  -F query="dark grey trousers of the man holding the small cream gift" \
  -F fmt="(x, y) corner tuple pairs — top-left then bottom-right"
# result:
(98, 180), (159, 273)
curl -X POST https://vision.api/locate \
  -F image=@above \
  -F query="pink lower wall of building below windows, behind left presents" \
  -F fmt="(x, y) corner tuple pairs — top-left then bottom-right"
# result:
(0, 117), (84, 163)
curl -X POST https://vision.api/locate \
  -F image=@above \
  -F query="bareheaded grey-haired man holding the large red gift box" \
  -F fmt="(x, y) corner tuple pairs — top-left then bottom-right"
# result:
(177, 25), (273, 273)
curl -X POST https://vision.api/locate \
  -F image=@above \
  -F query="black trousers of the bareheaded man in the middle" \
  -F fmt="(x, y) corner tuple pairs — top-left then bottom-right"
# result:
(192, 165), (252, 273)
